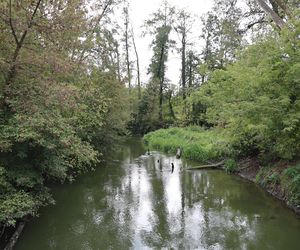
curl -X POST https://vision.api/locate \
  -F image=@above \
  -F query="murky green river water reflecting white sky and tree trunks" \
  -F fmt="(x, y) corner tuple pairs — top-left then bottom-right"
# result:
(16, 139), (300, 250)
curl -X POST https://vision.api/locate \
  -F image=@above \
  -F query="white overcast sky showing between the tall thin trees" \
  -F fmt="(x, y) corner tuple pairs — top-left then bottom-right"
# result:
(123, 0), (213, 88)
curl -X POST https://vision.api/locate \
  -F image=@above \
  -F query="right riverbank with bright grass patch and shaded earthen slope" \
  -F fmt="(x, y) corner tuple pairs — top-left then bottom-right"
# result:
(144, 127), (300, 215)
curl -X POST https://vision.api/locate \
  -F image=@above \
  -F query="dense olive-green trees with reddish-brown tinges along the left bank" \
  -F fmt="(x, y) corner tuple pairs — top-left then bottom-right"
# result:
(0, 0), (129, 228)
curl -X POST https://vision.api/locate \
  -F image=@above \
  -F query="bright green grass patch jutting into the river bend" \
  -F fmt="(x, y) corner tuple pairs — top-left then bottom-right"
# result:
(144, 126), (226, 162)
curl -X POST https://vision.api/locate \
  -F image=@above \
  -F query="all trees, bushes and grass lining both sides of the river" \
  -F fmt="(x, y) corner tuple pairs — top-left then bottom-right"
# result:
(0, 0), (300, 247)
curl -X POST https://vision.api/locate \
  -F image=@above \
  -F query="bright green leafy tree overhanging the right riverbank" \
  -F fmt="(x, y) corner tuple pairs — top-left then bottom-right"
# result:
(191, 16), (300, 159)
